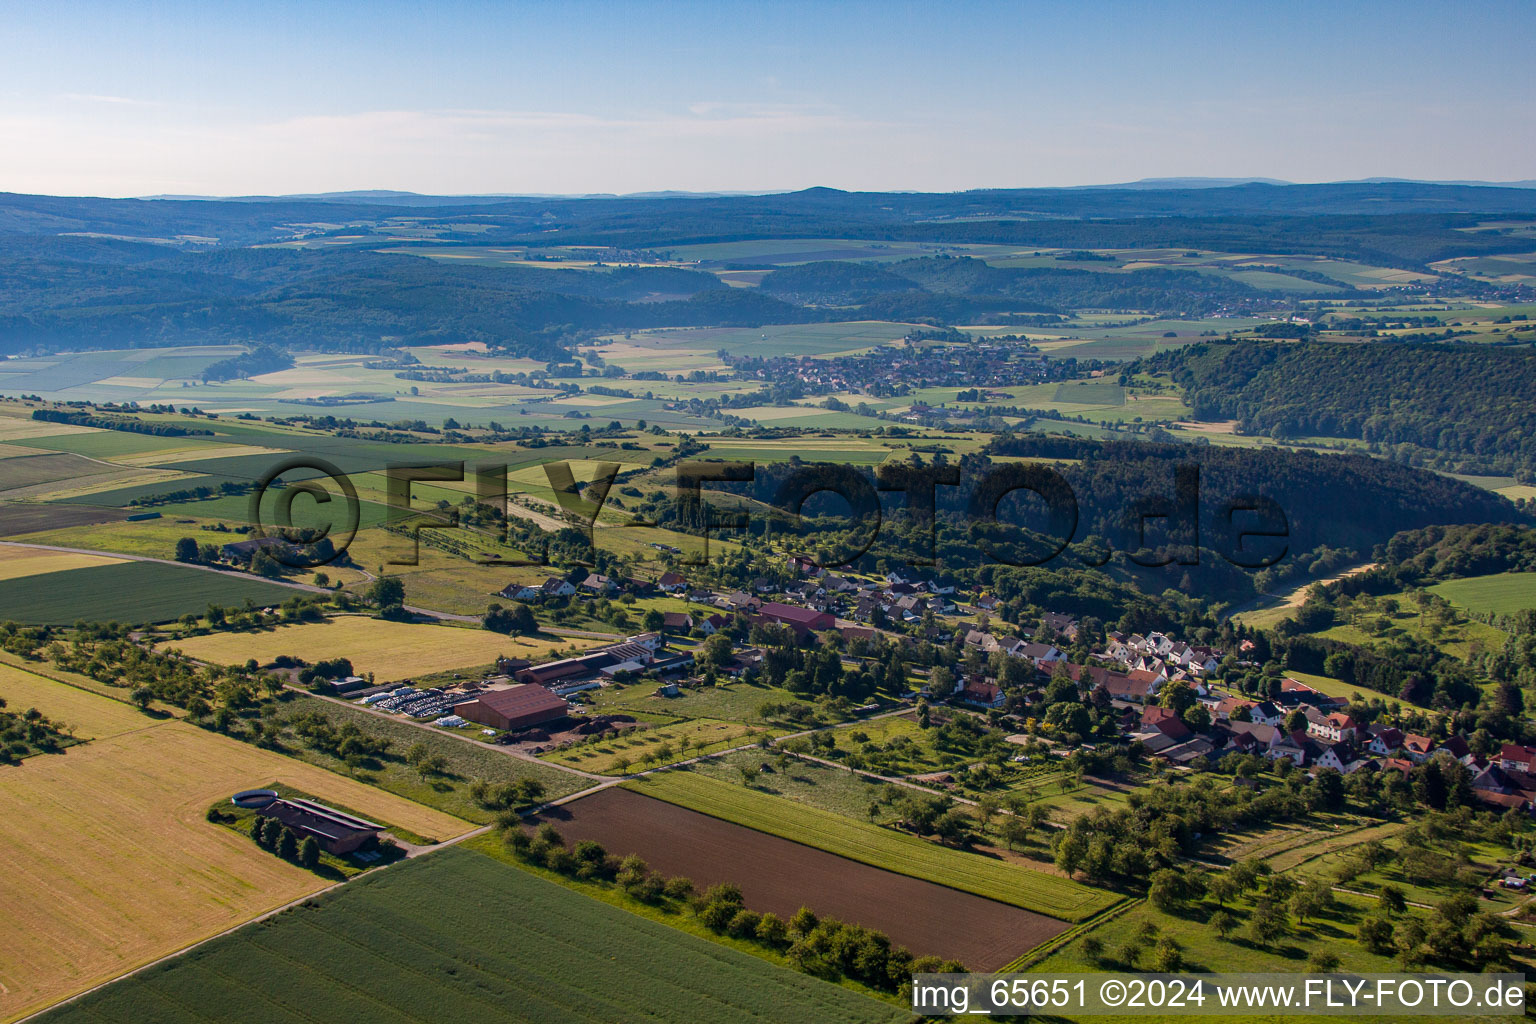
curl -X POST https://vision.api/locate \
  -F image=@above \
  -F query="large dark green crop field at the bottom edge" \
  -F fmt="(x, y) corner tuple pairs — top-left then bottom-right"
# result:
(33, 847), (906, 1024)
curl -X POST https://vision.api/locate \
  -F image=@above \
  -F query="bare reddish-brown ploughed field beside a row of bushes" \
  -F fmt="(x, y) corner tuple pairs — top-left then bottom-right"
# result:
(538, 789), (1068, 970)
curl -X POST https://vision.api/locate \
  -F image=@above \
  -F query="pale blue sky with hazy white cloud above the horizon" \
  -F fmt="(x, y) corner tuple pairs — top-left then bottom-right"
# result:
(0, 0), (1536, 197)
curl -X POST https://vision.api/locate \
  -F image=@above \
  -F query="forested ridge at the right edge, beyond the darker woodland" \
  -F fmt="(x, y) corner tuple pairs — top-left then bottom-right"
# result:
(1132, 341), (1536, 476)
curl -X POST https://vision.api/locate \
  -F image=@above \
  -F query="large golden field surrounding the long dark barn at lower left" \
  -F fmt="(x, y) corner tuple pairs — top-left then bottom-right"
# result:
(0, 669), (470, 1019)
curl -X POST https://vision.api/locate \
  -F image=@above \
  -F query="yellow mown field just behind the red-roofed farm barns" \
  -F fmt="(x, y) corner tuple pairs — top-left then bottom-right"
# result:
(164, 616), (593, 682)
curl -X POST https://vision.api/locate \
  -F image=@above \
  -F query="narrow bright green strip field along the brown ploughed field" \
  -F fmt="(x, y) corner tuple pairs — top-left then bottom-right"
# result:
(624, 771), (1118, 921)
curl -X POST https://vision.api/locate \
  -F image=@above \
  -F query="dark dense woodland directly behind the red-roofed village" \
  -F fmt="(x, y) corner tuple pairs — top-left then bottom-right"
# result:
(641, 434), (1527, 607)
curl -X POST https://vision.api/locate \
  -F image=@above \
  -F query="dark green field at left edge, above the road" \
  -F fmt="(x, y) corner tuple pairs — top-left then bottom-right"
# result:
(0, 562), (298, 625)
